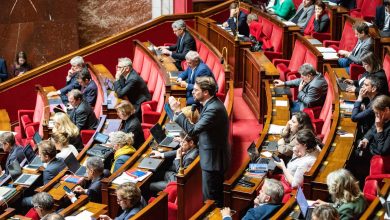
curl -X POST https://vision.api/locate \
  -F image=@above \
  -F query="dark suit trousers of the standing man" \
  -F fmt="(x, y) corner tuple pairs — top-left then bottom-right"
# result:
(202, 170), (224, 207)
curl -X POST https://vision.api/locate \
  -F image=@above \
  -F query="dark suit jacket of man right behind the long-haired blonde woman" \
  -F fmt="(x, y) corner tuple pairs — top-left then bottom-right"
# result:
(69, 100), (99, 131)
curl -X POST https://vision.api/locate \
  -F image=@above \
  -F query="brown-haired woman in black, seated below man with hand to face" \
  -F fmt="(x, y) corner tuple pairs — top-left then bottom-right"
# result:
(115, 100), (145, 149)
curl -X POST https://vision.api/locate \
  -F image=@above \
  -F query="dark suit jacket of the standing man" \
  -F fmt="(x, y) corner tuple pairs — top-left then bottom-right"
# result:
(174, 96), (230, 172)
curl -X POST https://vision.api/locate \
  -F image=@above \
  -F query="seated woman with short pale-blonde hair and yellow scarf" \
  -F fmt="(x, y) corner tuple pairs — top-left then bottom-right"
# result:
(108, 131), (136, 173)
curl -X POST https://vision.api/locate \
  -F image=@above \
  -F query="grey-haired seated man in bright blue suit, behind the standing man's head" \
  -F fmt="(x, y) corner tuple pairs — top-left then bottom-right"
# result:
(177, 51), (214, 105)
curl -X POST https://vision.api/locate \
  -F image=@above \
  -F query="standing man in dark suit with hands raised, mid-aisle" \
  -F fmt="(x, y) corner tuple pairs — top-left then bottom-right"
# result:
(169, 76), (230, 207)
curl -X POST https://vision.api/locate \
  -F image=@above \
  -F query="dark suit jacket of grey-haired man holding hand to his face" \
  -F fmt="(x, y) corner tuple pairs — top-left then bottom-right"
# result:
(114, 70), (151, 111)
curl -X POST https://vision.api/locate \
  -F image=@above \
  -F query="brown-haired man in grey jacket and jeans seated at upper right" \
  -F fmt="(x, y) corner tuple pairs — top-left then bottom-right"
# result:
(338, 22), (374, 73)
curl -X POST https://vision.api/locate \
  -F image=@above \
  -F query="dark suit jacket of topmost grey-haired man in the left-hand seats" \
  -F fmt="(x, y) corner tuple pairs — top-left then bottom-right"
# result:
(168, 31), (196, 61)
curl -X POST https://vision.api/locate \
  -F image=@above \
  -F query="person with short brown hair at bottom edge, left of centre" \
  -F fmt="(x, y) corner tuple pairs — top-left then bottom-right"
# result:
(99, 183), (146, 220)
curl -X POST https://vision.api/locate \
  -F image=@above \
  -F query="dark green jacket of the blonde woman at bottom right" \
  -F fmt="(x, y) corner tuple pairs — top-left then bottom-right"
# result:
(336, 195), (366, 220)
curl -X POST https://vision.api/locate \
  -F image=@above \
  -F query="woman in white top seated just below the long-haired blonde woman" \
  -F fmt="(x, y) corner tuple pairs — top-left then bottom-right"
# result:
(51, 132), (79, 160)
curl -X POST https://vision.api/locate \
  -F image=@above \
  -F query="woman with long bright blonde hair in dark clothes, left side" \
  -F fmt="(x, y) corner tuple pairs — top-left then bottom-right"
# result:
(53, 112), (84, 150)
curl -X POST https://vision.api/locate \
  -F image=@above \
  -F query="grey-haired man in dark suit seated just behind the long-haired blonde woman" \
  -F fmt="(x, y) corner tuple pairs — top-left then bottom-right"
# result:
(68, 89), (99, 131)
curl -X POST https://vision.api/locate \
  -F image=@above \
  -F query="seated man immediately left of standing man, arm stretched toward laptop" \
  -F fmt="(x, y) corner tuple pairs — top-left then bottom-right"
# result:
(150, 132), (199, 193)
